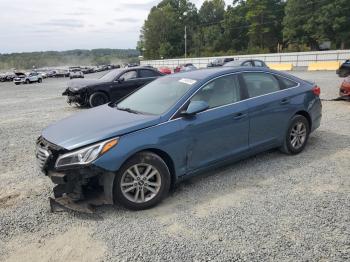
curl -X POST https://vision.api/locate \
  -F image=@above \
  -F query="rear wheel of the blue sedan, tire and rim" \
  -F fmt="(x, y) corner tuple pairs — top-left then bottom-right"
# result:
(280, 115), (310, 155)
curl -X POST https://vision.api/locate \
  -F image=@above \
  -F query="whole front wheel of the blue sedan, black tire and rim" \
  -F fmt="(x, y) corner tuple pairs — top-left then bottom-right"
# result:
(113, 151), (171, 210)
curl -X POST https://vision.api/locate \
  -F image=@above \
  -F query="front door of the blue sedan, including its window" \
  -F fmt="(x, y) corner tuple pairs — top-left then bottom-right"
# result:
(181, 74), (249, 173)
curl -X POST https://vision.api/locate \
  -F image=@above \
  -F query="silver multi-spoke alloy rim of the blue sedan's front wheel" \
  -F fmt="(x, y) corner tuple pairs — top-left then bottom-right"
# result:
(120, 163), (161, 203)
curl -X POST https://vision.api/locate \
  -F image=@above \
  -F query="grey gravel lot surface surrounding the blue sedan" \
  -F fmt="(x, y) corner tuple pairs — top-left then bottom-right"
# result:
(0, 72), (350, 261)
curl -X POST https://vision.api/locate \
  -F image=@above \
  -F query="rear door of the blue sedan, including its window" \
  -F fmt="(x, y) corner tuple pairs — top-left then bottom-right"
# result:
(241, 72), (294, 151)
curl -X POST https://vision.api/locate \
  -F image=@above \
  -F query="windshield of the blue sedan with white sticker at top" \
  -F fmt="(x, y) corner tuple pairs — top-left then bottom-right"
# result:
(116, 77), (197, 115)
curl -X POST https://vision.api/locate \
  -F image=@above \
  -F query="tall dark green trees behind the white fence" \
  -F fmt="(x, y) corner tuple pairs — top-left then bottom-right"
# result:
(137, 0), (350, 59)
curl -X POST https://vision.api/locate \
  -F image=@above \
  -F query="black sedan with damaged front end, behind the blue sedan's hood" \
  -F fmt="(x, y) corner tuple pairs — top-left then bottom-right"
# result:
(62, 67), (163, 107)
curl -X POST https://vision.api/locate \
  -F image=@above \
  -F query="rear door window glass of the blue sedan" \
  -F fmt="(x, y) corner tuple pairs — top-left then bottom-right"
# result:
(242, 72), (281, 98)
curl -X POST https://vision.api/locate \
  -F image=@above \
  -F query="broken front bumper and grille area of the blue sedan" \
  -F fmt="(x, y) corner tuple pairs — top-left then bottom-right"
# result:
(36, 138), (114, 213)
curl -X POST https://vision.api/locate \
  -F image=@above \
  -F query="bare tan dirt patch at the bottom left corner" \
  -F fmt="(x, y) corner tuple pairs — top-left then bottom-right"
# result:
(2, 227), (106, 262)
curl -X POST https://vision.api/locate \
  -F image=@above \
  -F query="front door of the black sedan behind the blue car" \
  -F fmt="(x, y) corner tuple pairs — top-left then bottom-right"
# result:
(110, 69), (139, 100)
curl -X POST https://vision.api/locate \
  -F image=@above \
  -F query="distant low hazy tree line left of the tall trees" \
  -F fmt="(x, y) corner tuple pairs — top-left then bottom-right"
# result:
(0, 49), (139, 70)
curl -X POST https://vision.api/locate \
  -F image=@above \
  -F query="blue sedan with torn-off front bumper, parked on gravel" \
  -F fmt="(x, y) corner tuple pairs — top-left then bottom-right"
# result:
(36, 67), (322, 210)
